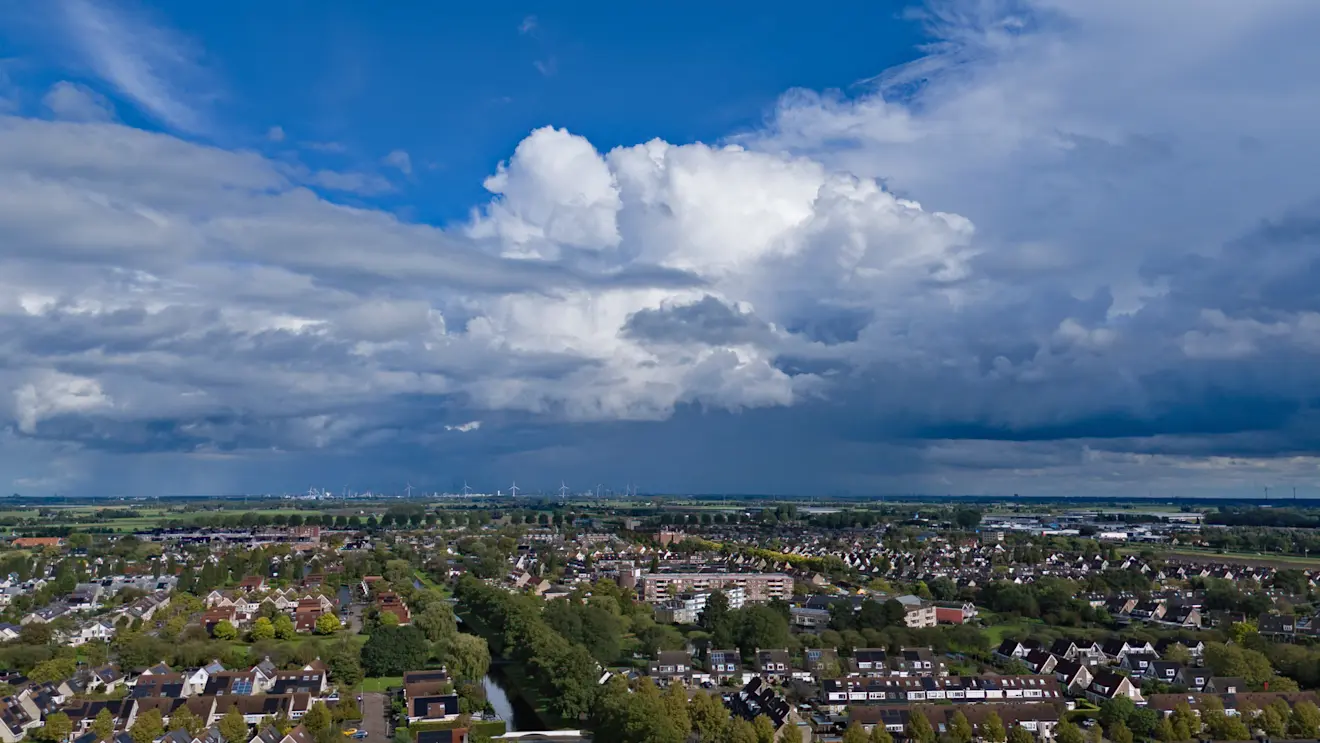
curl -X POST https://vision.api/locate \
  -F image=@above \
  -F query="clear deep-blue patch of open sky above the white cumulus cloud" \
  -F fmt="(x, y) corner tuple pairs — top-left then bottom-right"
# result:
(5, 1), (921, 222)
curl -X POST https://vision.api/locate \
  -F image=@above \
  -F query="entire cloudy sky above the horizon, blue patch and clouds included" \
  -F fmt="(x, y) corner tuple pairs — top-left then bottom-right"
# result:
(0, 0), (1320, 498)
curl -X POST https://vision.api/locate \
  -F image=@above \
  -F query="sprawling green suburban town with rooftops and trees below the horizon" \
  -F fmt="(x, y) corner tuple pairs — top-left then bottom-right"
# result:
(0, 498), (1320, 743)
